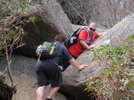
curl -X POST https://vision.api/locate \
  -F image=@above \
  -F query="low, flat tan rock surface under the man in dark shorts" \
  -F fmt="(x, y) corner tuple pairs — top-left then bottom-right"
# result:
(0, 54), (67, 100)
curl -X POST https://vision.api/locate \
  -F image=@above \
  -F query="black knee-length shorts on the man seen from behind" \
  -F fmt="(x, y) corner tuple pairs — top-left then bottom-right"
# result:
(35, 60), (62, 87)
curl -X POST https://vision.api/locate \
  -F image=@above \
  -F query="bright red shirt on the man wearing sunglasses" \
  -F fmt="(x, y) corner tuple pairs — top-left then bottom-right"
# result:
(68, 29), (100, 57)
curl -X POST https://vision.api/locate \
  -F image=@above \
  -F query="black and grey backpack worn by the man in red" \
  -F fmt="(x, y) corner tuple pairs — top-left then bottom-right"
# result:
(68, 27), (88, 46)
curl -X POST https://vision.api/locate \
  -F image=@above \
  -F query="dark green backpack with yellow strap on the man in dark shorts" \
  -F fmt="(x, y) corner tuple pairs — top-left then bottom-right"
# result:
(36, 41), (59, 60)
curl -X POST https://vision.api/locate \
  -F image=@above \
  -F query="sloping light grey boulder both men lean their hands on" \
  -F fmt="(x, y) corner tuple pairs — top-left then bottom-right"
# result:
(60, 14), (134, 100)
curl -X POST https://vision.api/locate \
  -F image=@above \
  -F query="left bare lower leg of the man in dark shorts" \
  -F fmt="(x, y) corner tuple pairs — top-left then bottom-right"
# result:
(36, 86), (46, 100)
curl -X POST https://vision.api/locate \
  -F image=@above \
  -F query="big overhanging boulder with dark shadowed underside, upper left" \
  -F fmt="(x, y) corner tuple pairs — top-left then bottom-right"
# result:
(15, 0), (73, 58)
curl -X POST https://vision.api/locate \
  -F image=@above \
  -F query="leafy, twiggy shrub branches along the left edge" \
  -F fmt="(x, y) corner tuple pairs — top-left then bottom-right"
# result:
(0, 0), (36, 90)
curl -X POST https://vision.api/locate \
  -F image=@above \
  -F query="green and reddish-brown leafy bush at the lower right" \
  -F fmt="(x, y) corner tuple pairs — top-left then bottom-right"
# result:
(85, 34), (134, 100)
